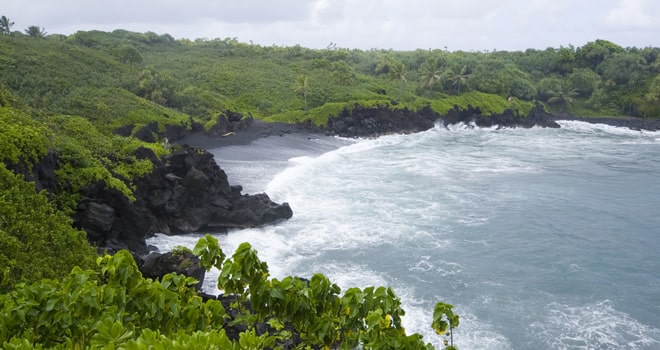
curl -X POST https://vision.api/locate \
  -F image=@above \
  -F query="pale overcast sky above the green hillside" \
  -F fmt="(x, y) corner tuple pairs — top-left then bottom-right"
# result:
(5, 0), (660, 51)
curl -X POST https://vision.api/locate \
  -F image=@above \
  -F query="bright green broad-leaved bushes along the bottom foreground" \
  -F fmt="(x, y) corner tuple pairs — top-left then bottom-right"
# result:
(0, 235), (459, 349)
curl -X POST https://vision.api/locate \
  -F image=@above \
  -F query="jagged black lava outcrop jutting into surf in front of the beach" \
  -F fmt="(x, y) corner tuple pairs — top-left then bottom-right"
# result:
(74, 148), (293, 255)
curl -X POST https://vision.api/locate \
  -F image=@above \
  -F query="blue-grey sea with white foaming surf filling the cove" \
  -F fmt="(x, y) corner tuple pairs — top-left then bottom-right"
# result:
(150, 122), (660, 349)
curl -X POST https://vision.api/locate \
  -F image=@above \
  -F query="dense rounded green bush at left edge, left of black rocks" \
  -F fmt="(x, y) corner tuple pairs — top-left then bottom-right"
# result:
(0, 163), (96, 292)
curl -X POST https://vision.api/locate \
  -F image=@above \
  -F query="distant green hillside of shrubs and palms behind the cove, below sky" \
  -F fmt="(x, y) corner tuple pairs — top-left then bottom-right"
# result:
(0, 30), (660, 131)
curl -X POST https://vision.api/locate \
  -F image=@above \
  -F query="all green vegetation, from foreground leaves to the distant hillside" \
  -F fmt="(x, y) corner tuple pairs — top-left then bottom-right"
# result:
(0, 16), (660, 349)
